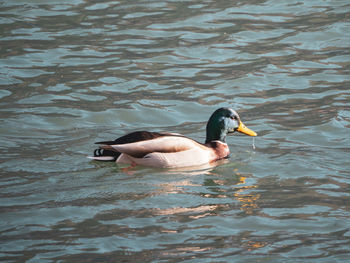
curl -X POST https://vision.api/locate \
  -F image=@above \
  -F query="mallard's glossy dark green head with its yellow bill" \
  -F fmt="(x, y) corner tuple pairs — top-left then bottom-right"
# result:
(205, 108), (257, 143)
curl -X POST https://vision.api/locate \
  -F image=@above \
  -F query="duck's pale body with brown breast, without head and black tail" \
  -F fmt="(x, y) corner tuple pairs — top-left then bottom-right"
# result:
(94, 135), (230, 168)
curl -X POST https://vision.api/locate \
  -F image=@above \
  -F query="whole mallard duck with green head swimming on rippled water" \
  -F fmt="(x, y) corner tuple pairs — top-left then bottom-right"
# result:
(88, 107), (257, 168)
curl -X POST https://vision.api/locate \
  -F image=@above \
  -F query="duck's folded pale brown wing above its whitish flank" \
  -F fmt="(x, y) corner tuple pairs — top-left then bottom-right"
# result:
(101, 134), (201, 158)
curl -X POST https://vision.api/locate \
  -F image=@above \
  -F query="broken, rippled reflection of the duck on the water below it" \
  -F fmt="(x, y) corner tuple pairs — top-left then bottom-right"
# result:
(145, 162), (260, 220)
